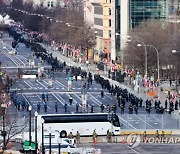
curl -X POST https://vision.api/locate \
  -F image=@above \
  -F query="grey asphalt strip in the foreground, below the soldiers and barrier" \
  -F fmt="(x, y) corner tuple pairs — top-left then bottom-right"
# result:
(78, 143), (180, 154)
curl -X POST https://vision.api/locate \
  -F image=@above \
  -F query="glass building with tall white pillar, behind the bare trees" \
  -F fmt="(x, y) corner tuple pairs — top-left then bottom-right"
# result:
(111, 0), (169, 64)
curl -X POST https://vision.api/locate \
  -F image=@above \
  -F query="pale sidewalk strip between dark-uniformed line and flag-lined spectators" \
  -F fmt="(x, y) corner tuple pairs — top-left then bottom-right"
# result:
(41, 44), (174, 105)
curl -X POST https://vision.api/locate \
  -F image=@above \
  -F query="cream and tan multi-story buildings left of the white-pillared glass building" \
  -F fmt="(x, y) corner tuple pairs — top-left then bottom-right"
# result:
(84, 0), (111, 61)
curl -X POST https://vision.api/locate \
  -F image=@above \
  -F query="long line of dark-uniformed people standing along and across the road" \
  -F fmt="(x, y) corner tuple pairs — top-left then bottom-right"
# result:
(6, 23), (180, 114)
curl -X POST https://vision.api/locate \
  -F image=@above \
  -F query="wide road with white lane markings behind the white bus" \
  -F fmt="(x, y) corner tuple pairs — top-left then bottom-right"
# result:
(0, 31), (179, 129)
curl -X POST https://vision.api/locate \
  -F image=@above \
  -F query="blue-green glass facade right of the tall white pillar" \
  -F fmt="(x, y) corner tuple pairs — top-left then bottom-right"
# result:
(129, 0), (168, 29)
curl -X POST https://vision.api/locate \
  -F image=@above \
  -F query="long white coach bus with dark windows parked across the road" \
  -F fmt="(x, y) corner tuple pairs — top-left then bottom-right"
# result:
(37, 113), (120, 143)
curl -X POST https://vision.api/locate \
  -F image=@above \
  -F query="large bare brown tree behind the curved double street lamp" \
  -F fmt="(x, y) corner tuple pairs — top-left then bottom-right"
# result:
(124, 20), (178, 79)
